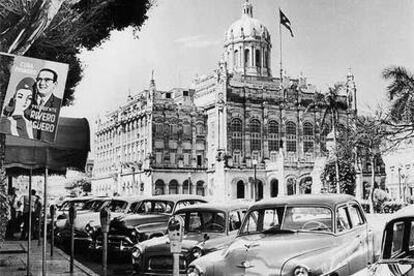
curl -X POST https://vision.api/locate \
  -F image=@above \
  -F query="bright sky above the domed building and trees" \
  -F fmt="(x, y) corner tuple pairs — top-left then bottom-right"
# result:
(61, 0), (414, 122)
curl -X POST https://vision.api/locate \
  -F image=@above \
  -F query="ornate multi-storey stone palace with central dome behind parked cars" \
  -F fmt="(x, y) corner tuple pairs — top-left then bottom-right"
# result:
(93, 1), (356, 200)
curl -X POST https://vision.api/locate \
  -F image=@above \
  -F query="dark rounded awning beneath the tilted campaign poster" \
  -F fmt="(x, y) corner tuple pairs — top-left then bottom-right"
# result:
(4, 117), (90, 176)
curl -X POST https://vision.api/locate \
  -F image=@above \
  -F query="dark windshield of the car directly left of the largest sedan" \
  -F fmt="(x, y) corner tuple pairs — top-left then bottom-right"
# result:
(177, 211), (226, 233)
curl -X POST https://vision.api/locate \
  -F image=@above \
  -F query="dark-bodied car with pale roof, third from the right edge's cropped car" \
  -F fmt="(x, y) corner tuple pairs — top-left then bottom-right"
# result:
(90, 194), (207, 254)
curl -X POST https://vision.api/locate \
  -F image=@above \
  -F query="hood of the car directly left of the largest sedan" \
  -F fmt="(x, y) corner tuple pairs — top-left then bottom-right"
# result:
(142, 233), (226, 253)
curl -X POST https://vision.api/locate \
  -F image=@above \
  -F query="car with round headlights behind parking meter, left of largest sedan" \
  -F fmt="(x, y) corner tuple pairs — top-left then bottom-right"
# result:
(131, 202), (248, 275)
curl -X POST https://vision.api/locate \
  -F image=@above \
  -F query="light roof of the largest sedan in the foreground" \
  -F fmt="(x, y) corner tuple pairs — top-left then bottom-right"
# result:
(251, 193), (357, 209)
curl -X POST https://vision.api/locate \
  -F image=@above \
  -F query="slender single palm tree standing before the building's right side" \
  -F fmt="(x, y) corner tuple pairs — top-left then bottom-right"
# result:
(305, 84), (345, 193)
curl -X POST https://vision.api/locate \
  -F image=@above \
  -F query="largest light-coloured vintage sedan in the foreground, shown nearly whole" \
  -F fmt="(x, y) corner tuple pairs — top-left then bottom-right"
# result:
(187, 194), (373, 276)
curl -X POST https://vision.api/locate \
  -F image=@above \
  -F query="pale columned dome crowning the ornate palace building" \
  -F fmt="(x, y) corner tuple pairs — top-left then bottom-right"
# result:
(224, 0), (272, 77)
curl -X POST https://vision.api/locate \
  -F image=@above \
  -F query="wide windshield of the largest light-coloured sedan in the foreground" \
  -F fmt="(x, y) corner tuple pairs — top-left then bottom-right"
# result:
(240, 206), (332, 235)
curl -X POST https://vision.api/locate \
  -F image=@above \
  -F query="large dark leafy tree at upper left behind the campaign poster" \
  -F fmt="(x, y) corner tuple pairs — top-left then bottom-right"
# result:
(0, 0), (155, 240)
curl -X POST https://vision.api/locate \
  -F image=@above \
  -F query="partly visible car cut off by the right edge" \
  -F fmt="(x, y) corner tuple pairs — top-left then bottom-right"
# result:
(353, 205), (414, 276)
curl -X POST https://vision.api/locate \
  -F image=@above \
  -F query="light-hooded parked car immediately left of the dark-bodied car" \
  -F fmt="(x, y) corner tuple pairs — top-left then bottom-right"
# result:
(58, 196), (142, 246)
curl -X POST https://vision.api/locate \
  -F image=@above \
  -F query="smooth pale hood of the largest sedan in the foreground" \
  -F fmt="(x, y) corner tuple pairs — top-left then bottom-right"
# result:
(223, 232), (336, 272)
